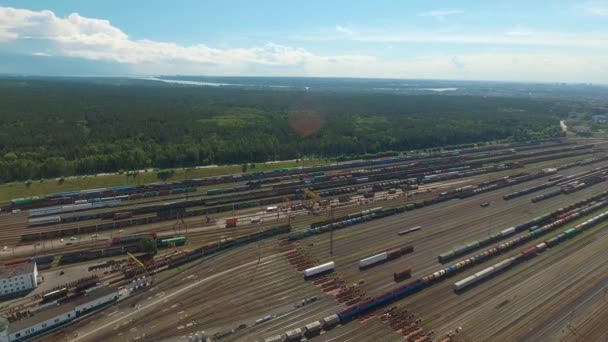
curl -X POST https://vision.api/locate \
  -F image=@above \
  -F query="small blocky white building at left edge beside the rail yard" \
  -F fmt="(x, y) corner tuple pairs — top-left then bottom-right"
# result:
(0, 262), (38, 298)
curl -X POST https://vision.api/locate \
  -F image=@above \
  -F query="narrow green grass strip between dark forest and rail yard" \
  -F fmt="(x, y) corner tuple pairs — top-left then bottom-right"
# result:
(0, 159), (332, 203)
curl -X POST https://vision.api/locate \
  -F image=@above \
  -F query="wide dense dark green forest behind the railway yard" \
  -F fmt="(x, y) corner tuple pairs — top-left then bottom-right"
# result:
(0, 78), (568, 182)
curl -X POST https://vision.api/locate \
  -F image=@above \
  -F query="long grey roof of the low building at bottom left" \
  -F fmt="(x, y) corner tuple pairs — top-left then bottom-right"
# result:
(8, 287), (118, 334)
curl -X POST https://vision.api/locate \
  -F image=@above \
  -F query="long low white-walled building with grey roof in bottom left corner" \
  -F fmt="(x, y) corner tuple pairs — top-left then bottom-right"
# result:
(0, 287), (119, 342)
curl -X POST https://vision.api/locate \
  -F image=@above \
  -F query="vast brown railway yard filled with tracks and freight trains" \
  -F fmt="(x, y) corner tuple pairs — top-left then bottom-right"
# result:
(0, 139), (608, 342)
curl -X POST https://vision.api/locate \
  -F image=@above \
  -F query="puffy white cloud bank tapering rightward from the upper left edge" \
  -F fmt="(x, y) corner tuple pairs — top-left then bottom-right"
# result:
(0, 7), (373, 74)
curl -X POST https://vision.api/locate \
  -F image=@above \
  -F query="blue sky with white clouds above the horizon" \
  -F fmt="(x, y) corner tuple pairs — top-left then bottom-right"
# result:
(0, 0), (608, 84)
